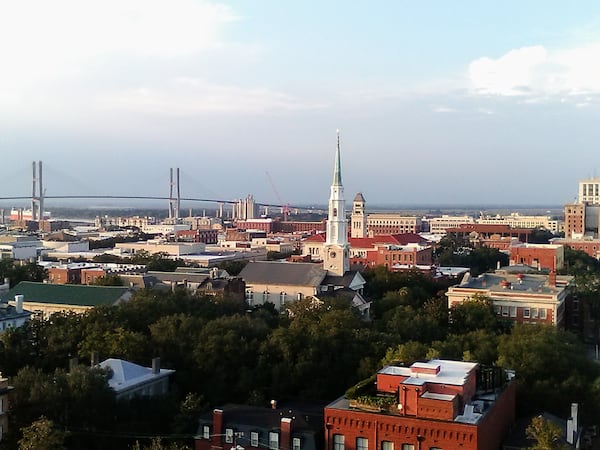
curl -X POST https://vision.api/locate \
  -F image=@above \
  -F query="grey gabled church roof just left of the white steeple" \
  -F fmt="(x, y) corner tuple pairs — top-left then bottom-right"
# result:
(239, 261), (327, 287)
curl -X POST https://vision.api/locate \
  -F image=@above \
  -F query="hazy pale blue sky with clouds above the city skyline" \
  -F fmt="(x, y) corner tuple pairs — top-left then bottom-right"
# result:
(0, 0), (600, 206)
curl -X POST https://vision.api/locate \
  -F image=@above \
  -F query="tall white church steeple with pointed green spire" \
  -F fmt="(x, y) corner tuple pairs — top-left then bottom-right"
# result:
(323, 131), (350, 276)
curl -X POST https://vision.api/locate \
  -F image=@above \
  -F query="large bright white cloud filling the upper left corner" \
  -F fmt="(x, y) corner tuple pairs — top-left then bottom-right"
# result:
(0, 0), (238, 89)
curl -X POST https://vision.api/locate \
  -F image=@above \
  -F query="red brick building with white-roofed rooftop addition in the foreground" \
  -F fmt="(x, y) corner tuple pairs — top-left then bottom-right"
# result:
(325, 360), (515, 450)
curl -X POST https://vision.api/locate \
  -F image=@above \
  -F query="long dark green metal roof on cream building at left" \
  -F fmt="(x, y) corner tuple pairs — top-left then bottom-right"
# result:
(6, 281), (129, 306)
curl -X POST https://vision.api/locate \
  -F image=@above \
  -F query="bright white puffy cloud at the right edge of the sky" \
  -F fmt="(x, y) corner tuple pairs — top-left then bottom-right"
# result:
(468, 43), (600, 99)
